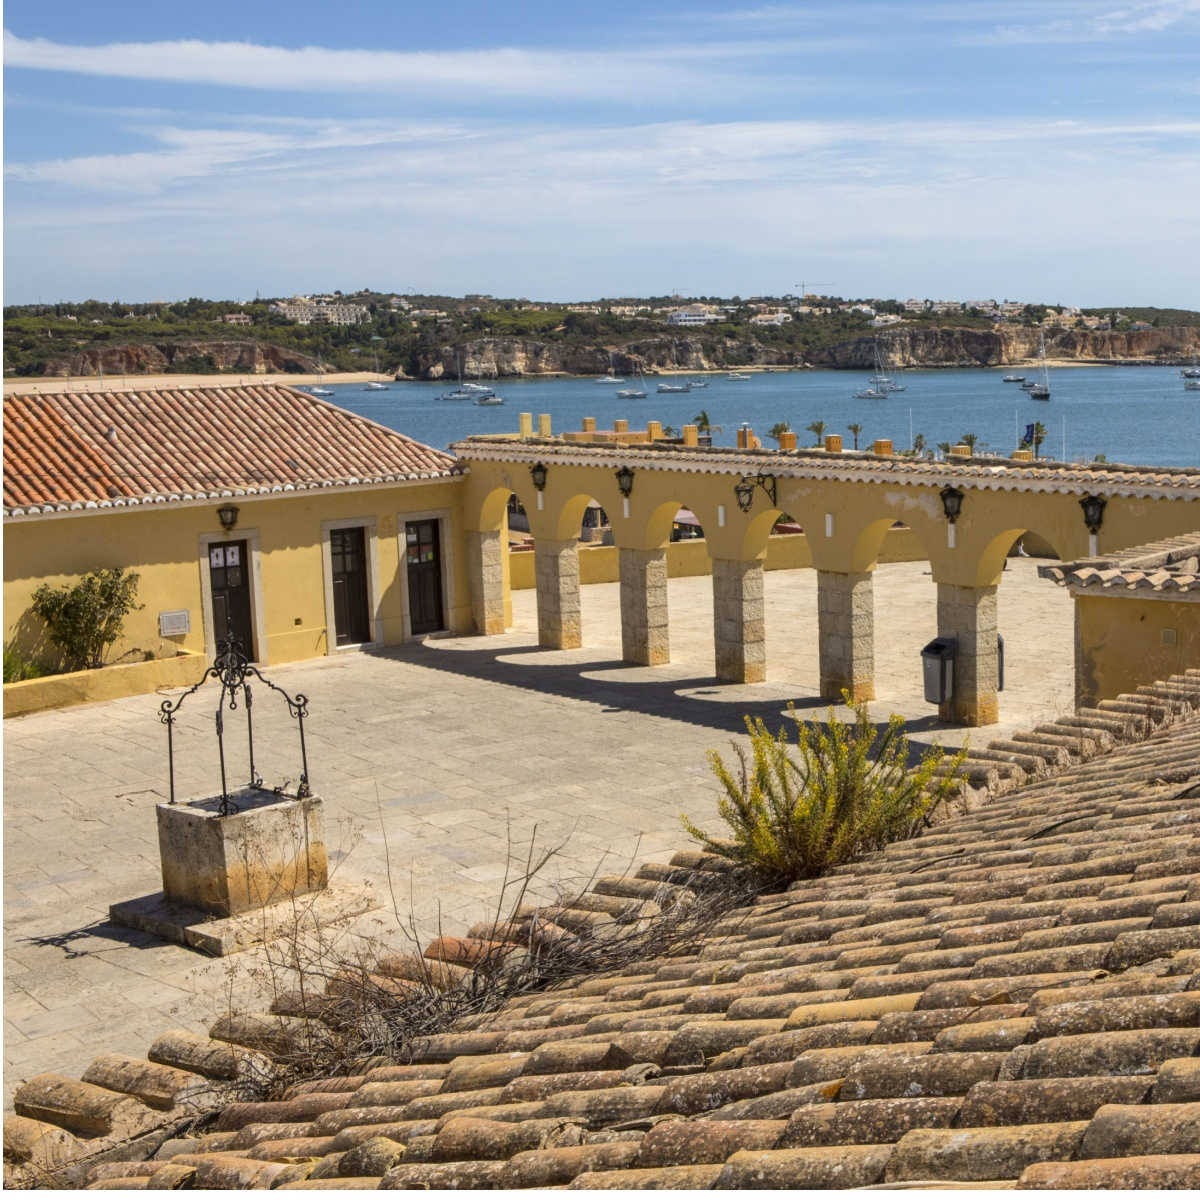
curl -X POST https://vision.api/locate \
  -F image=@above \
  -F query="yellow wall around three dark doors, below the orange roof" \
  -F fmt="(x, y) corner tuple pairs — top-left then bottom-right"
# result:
(4, 479), (472, 681)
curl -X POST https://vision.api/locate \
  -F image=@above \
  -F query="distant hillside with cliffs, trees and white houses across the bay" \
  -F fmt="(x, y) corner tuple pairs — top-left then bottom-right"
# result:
(4, 296), (1200, 379)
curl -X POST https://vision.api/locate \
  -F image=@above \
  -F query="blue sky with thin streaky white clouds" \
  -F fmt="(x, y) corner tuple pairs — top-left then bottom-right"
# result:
(4, 0), (1200, 308)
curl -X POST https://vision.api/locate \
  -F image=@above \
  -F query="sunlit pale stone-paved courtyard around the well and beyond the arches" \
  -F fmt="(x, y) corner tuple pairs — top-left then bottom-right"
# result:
(4, 559), (1073, 1104)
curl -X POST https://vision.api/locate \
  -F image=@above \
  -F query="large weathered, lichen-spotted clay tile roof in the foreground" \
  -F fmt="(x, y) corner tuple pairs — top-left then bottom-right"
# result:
(5, 671), (1200, 1189)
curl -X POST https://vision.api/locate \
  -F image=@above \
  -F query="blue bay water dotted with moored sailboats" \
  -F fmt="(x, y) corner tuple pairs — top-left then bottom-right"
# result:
(312, 366), (1200, 467)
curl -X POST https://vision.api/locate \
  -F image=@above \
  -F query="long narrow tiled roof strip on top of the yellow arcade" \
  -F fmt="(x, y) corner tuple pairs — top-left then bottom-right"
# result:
(450, 434), (1200, 499)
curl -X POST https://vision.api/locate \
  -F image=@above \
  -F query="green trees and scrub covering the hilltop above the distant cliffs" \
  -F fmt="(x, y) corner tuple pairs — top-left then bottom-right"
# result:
(4, 292), (1200, 376)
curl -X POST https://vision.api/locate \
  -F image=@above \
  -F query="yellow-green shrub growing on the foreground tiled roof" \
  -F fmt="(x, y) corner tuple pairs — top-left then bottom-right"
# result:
(683, 694), (966, 883)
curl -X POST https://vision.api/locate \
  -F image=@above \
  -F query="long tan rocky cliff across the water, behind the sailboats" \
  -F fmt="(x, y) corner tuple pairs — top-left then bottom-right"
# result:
(415, 326), (1200, 379)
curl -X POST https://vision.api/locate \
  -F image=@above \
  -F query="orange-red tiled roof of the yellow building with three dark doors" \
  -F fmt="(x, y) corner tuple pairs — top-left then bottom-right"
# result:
(4, 384), (458, 516)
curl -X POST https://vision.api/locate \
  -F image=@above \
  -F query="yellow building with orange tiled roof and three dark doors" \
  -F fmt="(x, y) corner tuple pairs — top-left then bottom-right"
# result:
(4, 385), (472, 712)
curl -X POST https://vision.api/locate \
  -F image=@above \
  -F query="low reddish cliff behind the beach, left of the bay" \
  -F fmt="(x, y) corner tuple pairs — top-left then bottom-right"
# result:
(43, 341), (317, 377)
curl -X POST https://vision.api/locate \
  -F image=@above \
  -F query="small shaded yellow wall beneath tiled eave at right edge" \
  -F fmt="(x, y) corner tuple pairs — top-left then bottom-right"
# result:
(1075, 595), (1200, 706)
